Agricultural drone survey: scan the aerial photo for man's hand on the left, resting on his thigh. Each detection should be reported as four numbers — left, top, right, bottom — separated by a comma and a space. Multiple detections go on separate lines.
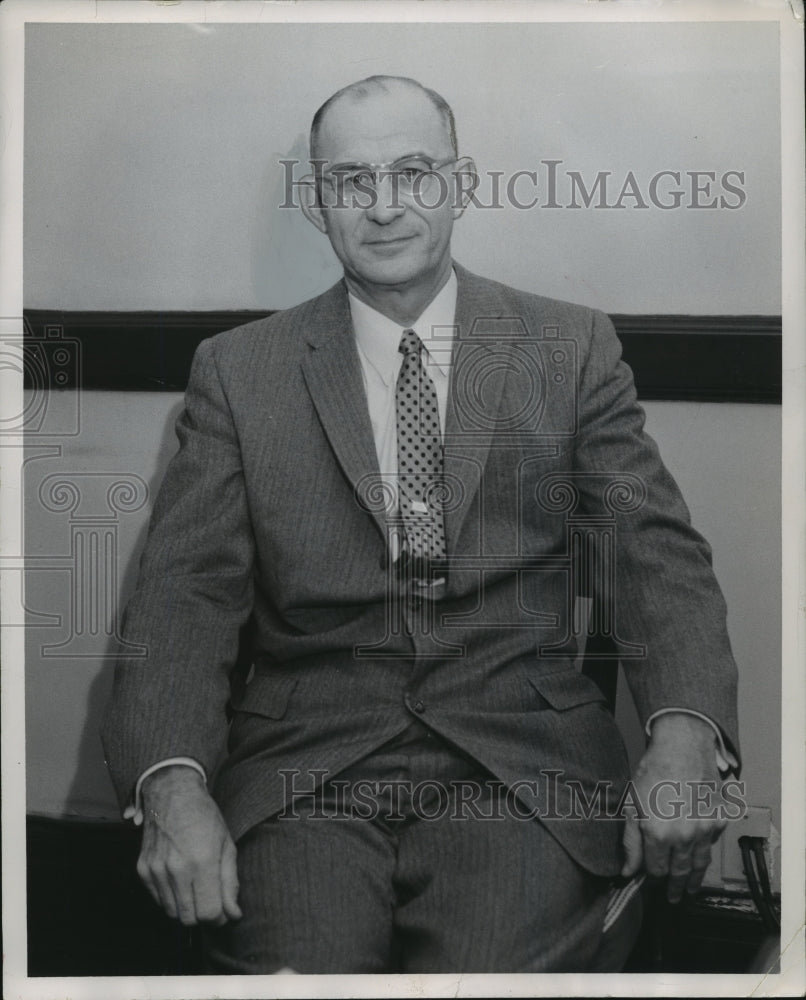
137, 764, 241, 926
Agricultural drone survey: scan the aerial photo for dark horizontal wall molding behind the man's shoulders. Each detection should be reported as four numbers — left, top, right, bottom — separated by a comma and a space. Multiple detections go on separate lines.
24, 309, 781, 403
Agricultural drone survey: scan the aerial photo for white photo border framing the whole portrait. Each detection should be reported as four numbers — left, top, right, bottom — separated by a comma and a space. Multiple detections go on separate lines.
0, 0, 806, 1000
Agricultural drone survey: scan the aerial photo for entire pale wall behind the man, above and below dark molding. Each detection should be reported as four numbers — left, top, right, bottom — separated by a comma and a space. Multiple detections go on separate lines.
25, 24, 780, 828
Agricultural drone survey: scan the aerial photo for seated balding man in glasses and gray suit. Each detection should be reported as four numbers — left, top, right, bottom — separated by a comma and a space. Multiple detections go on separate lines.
104, 77, 738, 972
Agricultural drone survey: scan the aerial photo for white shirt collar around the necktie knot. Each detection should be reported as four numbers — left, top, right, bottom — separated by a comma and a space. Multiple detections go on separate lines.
349, 269, 457, 385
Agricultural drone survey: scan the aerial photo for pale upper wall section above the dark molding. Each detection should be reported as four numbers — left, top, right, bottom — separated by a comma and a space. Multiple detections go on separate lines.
25, 23, 780, 314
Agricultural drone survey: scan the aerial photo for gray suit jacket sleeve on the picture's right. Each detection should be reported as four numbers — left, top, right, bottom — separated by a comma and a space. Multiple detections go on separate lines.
575, 312, 739, 759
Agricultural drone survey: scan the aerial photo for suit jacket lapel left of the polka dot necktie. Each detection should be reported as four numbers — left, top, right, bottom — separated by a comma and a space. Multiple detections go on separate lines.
302, 282, 386, 539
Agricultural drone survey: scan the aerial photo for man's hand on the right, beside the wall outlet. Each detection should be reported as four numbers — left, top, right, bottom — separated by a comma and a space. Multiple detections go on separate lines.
621, 712, 726, 903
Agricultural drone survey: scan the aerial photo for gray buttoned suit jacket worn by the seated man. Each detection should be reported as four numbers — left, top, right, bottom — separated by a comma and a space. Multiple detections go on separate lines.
103, 266, 738, 874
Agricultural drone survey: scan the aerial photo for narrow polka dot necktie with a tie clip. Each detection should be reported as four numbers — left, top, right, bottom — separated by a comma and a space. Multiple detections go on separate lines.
395, 330, 446, 579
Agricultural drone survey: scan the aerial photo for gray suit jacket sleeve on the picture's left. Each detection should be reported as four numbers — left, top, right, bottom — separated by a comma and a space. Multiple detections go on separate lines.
101, 339, 254, 808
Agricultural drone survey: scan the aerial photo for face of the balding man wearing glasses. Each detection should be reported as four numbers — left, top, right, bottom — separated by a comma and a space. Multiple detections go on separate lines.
315, 88, 460, 290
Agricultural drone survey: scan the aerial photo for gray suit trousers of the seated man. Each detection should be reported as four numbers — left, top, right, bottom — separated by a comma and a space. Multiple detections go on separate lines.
205, 719, 626, 974
